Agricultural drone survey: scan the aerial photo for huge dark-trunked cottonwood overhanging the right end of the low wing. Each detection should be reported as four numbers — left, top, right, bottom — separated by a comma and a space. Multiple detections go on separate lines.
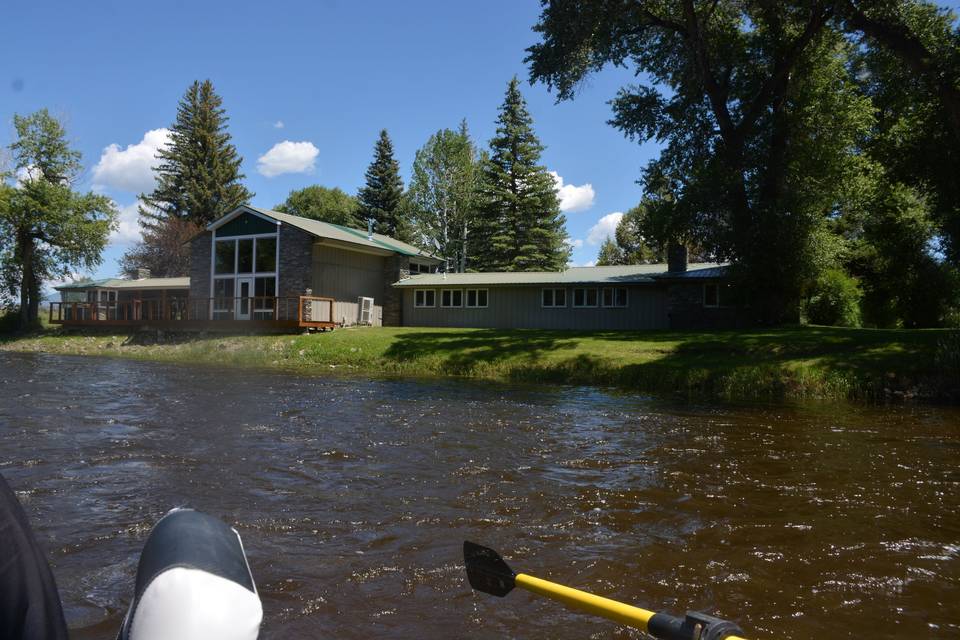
527, 0, 872, 323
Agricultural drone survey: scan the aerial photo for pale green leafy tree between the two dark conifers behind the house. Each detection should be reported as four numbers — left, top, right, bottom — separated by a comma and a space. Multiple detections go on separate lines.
408, 121, 479, 272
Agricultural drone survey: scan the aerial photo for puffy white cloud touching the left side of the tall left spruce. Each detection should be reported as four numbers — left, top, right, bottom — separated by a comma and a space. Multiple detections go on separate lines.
93, 129, 170, 193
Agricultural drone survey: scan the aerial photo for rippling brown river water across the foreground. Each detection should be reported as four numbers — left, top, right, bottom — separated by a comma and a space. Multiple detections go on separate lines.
0, 353, 960, 640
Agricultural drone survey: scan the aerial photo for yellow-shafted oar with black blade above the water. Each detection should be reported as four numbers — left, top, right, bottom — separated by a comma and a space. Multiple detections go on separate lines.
463, 541, 744, 640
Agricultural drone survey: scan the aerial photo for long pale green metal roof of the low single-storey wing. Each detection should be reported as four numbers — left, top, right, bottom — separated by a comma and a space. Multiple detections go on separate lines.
393, 263, 725, 287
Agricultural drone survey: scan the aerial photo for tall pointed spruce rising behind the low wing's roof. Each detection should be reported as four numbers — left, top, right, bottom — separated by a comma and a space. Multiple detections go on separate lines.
471, 77, 570, 271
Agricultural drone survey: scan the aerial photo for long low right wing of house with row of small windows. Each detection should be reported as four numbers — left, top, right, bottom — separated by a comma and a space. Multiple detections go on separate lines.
394, 255, 737, 331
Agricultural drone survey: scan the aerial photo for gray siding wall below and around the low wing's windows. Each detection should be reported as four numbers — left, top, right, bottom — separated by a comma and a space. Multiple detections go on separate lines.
403, 286, 669, 331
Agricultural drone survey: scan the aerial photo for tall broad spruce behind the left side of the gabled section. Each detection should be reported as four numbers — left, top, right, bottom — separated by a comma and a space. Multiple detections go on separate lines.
140, 80, 253, 227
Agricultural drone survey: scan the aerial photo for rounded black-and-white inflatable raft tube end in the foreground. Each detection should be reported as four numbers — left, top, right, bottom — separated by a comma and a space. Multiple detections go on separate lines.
117, 509, 263, 640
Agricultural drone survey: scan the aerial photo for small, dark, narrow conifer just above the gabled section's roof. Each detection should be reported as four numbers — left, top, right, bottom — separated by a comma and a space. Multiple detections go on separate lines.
357, 129, 410, 240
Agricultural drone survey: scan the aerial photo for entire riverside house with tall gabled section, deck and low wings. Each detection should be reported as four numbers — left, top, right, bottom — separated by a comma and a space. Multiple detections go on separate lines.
51, 206, 741, 330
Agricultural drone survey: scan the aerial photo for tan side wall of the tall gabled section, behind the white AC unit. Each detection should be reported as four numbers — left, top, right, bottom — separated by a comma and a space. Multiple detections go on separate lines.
313, 243, 386, 325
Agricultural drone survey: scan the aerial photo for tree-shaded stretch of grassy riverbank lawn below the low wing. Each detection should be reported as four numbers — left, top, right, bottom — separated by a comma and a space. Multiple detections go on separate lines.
385, 327, 956, 399
